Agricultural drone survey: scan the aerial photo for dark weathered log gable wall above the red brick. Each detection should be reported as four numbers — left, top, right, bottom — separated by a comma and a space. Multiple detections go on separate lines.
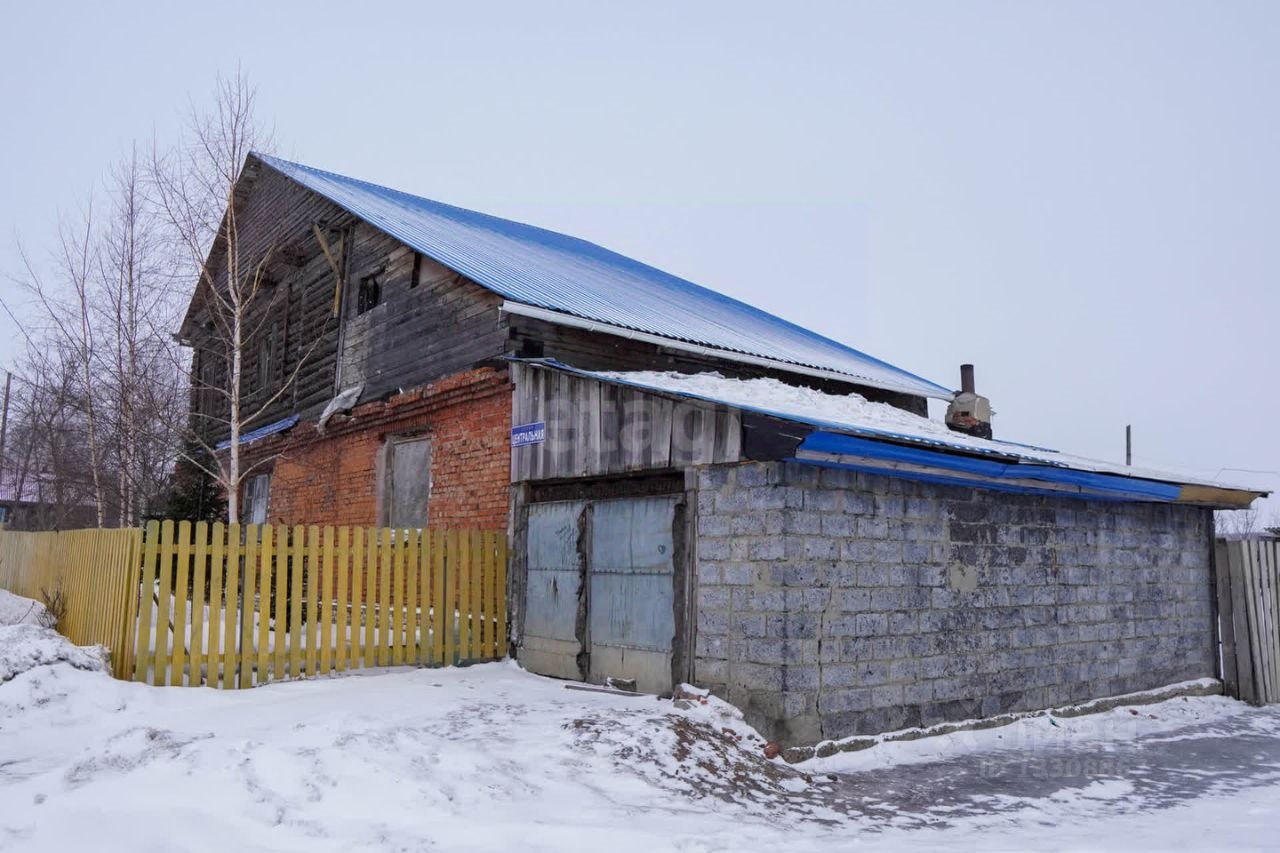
186, 160, 507, 442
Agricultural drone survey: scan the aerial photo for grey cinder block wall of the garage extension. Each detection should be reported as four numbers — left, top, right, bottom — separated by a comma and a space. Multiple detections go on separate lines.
695, 462, 1216, 743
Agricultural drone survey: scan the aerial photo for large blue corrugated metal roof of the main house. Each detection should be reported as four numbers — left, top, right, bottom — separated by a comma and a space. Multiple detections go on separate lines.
255, 155, 952, 400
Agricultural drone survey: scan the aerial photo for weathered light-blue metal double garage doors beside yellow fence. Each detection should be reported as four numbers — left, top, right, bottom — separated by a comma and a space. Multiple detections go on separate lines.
521, 496, 681, 693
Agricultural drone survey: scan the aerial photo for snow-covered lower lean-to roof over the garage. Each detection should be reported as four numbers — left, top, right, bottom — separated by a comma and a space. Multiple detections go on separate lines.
586, 365, 1267, 493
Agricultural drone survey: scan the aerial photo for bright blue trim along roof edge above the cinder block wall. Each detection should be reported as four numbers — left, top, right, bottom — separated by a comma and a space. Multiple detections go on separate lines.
797, 430, 1181, 502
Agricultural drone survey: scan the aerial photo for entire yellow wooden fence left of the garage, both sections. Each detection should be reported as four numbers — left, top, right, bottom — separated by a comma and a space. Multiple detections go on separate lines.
0, 521, 507, 688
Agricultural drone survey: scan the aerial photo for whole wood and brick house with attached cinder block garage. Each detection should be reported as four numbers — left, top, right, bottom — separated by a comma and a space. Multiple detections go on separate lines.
182, 155, 1261, 743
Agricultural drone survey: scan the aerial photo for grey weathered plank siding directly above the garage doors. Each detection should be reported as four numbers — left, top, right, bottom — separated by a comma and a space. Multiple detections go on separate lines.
511, 364, 742, 483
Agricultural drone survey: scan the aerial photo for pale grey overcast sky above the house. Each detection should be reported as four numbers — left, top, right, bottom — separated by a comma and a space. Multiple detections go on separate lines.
0, 0, 1280, 512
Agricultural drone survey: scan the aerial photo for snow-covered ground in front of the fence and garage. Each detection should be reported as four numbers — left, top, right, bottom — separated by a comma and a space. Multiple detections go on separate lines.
0, 625, 1280, 853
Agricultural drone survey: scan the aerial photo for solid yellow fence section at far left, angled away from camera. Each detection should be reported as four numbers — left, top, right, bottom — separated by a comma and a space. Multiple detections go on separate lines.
0, 529, 142, 679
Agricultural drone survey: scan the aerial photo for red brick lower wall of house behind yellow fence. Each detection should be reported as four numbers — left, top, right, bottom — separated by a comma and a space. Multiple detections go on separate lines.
246, 368, 512, 529
